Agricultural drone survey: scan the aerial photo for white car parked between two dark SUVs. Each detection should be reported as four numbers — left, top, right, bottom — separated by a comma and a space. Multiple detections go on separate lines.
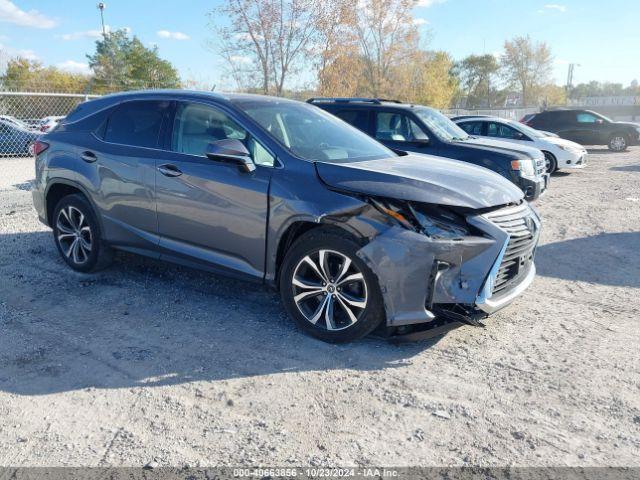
454, 117, 587, 173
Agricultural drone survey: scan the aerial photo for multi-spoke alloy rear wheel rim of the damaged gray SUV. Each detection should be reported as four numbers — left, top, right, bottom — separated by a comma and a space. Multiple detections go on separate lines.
56, 205, 93, 265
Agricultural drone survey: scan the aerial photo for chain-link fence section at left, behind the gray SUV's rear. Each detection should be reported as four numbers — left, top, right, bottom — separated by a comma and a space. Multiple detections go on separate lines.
0, 91, 96, 156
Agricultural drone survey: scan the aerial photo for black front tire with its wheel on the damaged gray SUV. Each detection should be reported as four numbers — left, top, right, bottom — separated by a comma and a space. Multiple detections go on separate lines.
279, 229, 385, 343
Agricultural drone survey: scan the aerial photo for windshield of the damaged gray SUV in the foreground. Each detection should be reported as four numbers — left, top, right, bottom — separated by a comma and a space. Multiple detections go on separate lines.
232, 99, 396, 163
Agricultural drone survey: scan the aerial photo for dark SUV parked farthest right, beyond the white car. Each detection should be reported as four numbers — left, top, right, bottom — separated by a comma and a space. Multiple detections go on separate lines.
520, 110, 640, 152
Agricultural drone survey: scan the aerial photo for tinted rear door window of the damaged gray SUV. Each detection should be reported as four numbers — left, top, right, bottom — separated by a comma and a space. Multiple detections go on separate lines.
104, 100, 170, 148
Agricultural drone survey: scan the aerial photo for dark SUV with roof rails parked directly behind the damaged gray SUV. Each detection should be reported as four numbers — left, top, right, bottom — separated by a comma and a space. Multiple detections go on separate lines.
307, 98, 549, 200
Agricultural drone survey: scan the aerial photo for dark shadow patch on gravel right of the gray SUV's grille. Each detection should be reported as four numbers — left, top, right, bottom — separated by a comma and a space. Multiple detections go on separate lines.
536, 232, 640, 288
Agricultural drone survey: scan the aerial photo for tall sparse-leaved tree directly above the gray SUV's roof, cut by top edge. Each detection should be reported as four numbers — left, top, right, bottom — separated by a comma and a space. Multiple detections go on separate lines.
210, 0, 323, 95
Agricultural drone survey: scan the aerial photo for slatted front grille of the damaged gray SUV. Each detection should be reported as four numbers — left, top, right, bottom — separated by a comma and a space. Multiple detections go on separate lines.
486, 204, 537, 294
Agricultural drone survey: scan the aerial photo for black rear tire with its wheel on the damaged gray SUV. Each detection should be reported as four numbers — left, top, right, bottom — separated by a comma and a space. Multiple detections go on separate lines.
51, 194, 113, 273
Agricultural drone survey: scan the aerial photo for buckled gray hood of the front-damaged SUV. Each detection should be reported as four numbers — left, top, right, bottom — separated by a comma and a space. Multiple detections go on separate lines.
315, 155, 524, 209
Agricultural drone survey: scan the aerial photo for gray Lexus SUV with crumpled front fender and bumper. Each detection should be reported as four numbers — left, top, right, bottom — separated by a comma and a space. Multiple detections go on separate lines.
33, 91, 540, 342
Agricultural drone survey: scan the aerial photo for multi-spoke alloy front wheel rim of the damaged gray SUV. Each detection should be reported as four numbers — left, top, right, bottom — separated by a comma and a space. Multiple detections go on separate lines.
291, 250, 367, 331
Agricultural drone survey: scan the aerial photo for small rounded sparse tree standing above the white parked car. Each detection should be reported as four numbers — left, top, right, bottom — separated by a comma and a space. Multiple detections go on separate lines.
500, 36, 553, 105
